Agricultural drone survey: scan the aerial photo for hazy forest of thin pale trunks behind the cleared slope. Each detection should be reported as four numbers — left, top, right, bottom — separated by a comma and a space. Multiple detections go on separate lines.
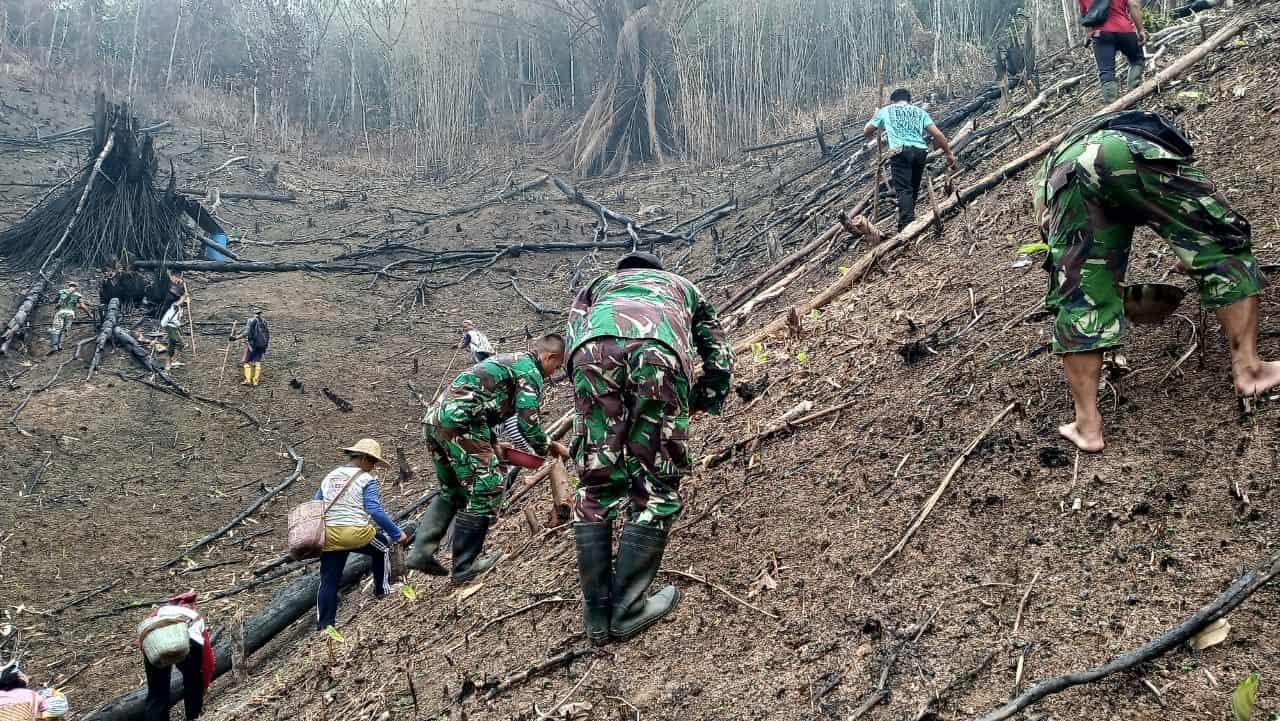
0, 0, 1157, 177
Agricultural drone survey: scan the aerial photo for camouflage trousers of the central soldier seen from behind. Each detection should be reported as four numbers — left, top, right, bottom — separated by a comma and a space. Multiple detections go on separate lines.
572, 338, 692, 528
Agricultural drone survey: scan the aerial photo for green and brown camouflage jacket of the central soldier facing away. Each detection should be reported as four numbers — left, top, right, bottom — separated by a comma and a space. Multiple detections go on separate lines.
566, 269, 733, 414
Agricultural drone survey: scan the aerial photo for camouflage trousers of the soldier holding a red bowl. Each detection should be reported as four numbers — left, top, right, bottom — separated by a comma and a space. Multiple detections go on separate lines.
422, 423, 503, 516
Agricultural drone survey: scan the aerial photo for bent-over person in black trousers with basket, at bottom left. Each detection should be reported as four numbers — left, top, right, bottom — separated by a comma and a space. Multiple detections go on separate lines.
138, 593, 214, 721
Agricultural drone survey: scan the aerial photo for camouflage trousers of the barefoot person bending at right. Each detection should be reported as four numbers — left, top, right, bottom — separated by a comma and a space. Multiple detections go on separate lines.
1044, 134, 1267, 353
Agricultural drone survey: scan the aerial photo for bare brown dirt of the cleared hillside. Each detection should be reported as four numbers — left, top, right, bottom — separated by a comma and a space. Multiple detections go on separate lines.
0, 7, 1280, 721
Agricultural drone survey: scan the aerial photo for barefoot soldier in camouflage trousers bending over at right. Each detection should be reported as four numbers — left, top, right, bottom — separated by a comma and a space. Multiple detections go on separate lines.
1034, 112, 1280, 452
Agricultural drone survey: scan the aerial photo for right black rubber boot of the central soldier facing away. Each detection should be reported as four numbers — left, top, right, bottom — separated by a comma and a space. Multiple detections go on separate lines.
609, 524, 680, 640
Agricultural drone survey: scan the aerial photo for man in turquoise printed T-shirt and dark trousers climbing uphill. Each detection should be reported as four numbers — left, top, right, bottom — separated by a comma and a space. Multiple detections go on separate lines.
863, 87, 956, 231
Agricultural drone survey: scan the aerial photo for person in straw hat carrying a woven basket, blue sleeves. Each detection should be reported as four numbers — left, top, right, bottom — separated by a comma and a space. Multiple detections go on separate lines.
315, 438, 408, 630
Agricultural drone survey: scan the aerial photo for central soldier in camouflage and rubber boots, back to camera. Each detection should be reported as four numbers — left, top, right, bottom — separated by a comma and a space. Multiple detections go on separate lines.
568, 254, 733, 644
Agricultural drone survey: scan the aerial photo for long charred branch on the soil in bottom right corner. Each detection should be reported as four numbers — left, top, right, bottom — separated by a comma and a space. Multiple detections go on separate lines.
977, 553, 1280, 721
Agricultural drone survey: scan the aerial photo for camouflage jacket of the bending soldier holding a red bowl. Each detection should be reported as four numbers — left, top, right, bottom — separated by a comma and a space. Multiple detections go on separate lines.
422, 352, 548, 456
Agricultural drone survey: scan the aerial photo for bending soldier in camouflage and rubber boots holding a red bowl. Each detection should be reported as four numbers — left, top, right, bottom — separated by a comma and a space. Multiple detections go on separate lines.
404, 334, 568, 583
